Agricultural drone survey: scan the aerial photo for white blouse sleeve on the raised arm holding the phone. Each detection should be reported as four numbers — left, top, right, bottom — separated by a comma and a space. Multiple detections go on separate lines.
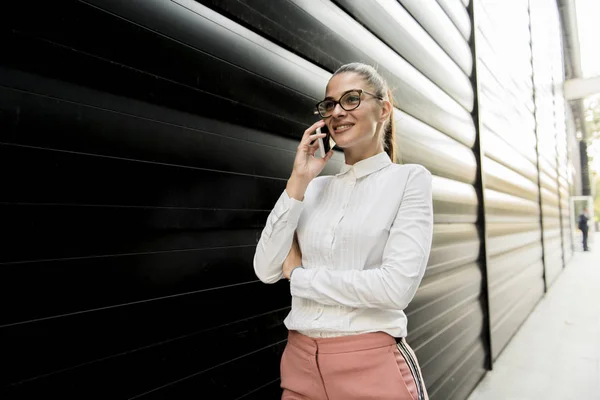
254, 190, 303, 283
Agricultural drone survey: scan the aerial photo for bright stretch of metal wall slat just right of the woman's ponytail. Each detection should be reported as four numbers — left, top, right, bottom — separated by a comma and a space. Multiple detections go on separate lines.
394, 110, 477, 184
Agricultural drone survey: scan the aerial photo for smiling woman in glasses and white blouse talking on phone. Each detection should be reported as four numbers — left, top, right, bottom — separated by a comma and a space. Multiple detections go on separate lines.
254, 63, 433, 400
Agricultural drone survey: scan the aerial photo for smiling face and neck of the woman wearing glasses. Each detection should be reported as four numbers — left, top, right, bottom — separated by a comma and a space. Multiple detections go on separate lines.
324, 72, 391, 164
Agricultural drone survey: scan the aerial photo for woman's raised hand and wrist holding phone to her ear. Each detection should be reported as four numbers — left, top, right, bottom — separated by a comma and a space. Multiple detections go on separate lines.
286, 120, 333, 200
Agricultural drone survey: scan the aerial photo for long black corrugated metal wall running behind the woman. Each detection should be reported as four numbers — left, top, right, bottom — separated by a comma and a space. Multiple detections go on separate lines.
0, 0, 569, 400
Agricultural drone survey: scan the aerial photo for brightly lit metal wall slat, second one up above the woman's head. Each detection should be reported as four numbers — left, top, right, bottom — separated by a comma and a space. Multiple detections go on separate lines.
336, 0, 474, 111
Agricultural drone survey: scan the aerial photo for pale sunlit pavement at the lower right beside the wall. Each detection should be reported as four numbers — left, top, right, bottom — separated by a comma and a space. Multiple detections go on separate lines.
468, 233, 600, 400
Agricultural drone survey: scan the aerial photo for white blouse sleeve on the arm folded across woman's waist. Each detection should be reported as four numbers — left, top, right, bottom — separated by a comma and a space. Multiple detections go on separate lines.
284, 167, 433, 310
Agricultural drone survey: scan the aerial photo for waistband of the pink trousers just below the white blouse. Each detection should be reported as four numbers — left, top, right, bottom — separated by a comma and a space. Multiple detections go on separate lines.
288, 331, 396, 355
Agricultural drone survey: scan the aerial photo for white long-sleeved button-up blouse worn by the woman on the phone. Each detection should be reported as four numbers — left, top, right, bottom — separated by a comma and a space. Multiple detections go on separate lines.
254, 152, 433, 337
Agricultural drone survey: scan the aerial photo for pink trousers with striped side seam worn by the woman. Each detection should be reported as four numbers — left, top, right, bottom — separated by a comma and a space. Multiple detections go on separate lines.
281, 331, 428, 400
